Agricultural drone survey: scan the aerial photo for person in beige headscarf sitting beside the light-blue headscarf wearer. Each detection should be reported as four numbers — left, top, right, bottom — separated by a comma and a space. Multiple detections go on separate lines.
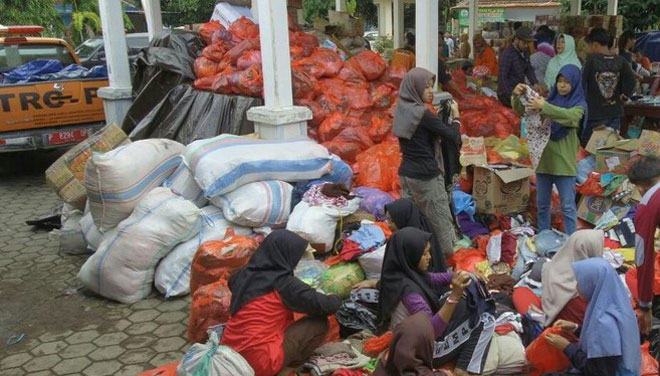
513, 230, 604, 342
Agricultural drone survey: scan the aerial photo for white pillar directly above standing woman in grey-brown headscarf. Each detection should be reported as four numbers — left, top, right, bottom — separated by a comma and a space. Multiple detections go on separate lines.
415, 0, 438, 78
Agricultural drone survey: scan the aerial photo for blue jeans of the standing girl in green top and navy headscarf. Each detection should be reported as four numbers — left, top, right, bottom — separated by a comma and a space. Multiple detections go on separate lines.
536, 174, 577, 235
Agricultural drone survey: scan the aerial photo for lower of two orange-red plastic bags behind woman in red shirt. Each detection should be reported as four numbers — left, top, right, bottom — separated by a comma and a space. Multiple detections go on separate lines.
188, 279, 231, 343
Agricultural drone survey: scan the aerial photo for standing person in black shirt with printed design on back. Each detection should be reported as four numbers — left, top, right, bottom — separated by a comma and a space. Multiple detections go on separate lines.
580, 27, 636, 146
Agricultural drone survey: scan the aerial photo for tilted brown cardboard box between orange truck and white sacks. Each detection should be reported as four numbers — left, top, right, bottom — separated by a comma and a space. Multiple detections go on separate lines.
46, 124, 131, 210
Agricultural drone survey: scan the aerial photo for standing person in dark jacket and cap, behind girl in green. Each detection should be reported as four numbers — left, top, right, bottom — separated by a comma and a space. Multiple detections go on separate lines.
497, 26, 539, 108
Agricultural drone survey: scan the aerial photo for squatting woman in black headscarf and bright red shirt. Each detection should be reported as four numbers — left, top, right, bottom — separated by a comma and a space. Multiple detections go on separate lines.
222, 230, 342, 376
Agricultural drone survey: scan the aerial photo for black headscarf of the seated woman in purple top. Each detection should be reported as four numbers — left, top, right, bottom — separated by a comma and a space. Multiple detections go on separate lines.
378, 227, 440, 332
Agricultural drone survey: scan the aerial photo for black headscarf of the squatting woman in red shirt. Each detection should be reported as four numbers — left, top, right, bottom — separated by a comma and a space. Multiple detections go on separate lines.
229, 230, 307, 315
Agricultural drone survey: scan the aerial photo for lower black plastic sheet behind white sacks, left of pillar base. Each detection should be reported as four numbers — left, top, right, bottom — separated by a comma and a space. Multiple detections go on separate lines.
129, 84, 262, 145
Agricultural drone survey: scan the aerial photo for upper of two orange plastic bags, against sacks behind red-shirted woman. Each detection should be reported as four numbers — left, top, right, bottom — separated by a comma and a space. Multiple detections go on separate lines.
190, 228, 259, 295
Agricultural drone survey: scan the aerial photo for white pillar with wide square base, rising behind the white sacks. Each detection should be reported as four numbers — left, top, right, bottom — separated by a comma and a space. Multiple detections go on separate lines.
247, 0, 312, 139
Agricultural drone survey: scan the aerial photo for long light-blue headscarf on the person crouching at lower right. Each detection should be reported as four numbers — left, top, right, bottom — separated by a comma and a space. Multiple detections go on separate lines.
572, 258, 641, 375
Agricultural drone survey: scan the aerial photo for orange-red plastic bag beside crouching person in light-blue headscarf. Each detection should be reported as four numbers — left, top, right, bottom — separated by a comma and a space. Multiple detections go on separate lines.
525, 326, 571, 376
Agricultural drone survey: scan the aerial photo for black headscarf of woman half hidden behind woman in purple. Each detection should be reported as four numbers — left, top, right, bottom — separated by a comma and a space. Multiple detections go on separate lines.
385, 198, 447, 273
